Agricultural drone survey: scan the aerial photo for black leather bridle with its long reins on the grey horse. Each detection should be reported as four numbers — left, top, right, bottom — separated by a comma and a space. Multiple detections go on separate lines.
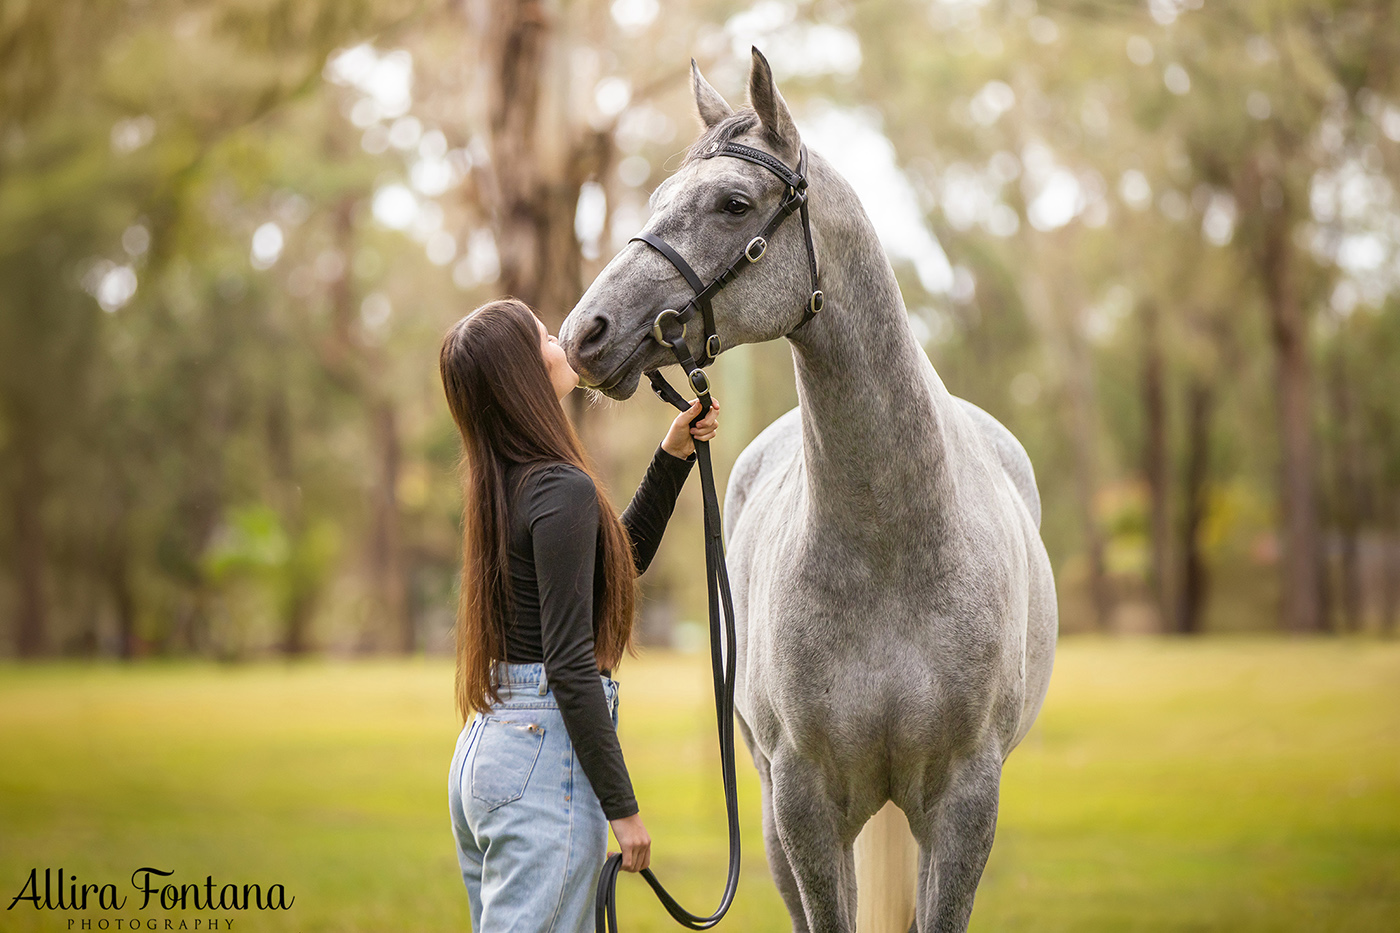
594, 143, 825, 933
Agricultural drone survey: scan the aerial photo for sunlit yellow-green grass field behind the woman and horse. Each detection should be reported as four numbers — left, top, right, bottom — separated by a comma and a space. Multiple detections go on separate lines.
0, 639, 1400, 933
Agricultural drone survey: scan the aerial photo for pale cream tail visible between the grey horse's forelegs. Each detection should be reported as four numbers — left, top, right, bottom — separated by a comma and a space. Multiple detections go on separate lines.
855, 803, 918, 933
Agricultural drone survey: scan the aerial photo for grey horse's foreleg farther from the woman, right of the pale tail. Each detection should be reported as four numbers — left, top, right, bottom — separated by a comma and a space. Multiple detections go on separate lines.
909, 749, 1001, 933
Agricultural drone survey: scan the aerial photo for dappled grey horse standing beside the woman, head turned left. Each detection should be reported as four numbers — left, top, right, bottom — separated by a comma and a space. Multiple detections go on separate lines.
560, 49, 1058, 933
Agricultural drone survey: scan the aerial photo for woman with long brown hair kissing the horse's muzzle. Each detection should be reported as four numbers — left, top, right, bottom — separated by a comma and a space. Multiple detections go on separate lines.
440, 298, 720, 933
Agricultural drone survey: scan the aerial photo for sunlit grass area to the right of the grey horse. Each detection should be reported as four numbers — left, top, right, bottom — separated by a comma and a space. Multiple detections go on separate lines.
973, 640, 1400, 930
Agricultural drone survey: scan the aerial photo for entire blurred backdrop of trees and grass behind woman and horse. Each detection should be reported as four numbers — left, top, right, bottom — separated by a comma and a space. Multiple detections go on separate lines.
0, 0, 1400, 930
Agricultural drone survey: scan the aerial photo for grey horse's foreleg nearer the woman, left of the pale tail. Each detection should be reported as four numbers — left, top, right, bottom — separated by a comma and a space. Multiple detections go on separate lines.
769, 751, 855, 933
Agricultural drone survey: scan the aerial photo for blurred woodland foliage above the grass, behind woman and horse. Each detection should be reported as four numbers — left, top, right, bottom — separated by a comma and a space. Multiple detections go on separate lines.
0, 0, 1400, 657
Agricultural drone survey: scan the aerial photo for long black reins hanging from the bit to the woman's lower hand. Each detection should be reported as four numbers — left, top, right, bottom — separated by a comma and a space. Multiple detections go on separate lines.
594, 343, 739, 933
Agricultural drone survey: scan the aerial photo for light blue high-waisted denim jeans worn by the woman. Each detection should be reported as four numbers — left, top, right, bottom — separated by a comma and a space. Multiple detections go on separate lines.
448, 663, 617, 933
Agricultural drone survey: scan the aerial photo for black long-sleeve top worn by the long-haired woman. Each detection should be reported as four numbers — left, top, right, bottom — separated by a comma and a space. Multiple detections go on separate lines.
505, 444, 694, 820
